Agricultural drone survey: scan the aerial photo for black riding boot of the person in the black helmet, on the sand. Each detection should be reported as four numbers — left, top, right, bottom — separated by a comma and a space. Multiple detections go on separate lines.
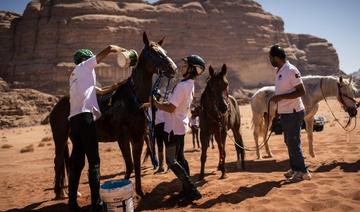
170, 162, 201, 202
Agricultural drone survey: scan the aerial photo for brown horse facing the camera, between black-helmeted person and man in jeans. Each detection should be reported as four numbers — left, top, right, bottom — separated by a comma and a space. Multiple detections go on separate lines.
200, 64, 245, 180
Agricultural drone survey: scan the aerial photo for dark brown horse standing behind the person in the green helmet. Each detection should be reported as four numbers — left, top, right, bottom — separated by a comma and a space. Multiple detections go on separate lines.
50, 32, 176, 198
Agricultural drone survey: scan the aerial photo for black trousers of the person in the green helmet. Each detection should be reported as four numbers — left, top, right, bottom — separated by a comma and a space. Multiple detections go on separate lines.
69, 113, 100, 205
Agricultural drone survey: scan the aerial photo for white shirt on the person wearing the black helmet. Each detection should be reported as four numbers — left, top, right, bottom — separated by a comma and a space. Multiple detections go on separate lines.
164, 79, 195, 135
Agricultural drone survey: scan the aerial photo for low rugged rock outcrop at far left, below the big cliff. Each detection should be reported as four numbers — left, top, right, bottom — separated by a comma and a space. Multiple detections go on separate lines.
0, 78, 58, 129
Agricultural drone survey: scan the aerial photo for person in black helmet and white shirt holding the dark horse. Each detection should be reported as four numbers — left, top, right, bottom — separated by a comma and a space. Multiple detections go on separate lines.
154, 55, 205, 203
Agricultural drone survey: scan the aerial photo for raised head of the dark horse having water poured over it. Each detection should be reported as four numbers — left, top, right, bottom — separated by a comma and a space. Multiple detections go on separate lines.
138, 32, 177, 78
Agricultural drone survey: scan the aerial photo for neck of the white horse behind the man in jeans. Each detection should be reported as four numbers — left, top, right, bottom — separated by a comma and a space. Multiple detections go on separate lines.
310, 77, 338, 102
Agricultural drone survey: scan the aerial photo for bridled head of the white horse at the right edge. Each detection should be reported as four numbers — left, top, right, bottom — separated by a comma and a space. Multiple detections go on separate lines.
337, 76, 359, 117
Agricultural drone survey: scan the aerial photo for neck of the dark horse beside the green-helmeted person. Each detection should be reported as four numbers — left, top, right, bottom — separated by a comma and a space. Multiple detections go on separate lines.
131, 64, 152, 102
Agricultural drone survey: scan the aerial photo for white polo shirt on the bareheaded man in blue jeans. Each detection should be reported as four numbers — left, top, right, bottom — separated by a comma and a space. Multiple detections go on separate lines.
275, 61, 304, 114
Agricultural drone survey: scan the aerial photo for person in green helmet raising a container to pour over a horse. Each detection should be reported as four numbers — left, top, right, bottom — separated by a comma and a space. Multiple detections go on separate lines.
68, 45, 124, 211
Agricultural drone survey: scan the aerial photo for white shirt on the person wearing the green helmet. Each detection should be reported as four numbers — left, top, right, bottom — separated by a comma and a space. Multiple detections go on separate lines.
68, 56, 101, 120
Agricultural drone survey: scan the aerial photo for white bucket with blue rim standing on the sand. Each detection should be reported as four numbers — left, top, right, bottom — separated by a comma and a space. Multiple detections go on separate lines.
100, 180, 134, 212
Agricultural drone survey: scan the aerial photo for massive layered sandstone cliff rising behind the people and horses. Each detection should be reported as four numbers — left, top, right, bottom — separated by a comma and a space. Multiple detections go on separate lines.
0, 0, 339, 93
